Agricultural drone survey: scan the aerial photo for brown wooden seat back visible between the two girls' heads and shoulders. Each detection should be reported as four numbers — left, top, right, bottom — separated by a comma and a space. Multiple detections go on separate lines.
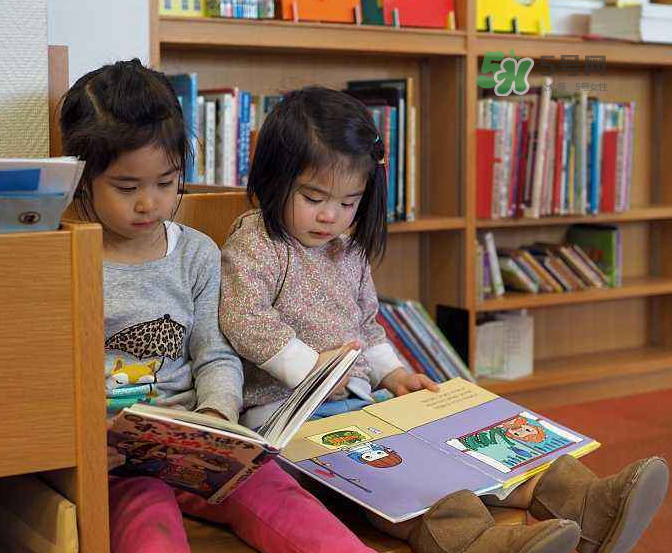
175, 191, 250, 246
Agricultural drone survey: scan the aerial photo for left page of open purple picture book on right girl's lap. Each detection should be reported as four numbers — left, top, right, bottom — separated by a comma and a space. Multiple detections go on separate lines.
281, 411, 499, 522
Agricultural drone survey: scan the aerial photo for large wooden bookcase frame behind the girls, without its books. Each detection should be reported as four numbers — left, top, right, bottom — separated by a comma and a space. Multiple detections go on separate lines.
150, 0, 672, 406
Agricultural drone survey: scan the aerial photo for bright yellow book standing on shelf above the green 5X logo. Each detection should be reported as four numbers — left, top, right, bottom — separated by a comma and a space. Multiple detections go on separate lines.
476, 0, 551, 35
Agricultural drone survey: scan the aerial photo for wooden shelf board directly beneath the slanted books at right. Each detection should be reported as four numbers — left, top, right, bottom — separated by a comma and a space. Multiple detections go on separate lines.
476, 277, 672, 312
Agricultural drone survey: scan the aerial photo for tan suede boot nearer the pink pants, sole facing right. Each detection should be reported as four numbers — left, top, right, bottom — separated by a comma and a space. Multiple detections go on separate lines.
409, 490, 579, 553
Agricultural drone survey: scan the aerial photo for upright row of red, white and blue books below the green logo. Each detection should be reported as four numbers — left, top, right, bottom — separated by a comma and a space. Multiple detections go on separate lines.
477, 78, 635, 219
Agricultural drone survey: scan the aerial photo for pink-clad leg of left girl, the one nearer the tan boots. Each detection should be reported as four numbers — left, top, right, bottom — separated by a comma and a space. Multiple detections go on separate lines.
176, 462, 375, 553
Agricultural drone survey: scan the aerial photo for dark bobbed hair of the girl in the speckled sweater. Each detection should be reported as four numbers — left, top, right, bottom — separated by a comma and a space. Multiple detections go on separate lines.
247, 86, 387, 259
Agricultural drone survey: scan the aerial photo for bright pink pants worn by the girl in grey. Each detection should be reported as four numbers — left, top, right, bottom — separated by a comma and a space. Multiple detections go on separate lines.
110, 462, 375, 553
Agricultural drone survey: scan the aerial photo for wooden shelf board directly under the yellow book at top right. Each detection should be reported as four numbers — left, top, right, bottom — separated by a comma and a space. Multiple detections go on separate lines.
473, 33, 672, 67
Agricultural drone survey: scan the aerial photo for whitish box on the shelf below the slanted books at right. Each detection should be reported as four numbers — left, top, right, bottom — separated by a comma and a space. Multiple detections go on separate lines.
475, 309, 534, 380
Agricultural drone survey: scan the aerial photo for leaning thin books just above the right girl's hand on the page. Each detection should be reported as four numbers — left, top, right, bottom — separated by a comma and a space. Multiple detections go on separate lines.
377, 298, 473, 382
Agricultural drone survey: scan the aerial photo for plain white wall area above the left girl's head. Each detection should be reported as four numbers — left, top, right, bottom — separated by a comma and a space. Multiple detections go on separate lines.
47, 0, 149, 85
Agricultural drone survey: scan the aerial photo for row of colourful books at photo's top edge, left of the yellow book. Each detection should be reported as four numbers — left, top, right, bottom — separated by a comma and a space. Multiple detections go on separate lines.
159, 0, 455, 29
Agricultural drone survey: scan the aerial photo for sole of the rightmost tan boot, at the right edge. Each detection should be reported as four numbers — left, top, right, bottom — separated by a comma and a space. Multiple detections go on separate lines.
598, 458, 670, 553
